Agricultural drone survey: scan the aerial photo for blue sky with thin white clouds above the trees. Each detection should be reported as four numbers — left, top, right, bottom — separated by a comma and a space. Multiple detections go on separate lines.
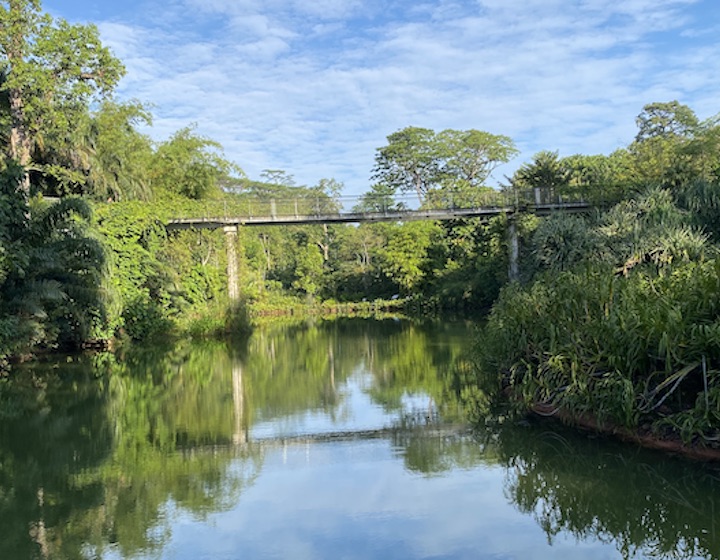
44, 0, 720, 194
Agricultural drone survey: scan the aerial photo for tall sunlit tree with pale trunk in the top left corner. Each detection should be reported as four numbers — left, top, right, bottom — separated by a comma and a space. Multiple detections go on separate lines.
0, 0, 125, 195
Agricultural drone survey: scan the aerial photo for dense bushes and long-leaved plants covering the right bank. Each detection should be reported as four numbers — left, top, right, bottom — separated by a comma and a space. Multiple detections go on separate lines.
482, 102, 720, 445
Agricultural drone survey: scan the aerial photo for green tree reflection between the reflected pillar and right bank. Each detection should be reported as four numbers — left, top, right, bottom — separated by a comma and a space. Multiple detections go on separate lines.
243, 319, 472, 423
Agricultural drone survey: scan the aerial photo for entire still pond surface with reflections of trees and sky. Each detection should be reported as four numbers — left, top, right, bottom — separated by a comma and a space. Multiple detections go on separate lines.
0, 319, 720, 560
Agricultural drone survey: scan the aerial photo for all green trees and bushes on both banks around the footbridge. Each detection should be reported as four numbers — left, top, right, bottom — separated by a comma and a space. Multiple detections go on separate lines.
0, 0, 720, 450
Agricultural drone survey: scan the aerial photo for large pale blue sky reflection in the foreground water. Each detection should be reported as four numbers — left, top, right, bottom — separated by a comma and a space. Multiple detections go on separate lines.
153, 440, 616, 560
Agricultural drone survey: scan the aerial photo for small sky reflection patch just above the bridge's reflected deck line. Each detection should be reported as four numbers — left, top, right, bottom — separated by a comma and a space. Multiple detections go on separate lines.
250, 370, 429, 441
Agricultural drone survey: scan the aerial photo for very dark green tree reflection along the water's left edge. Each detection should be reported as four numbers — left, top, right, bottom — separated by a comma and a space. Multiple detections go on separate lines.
0, 363, 112, 558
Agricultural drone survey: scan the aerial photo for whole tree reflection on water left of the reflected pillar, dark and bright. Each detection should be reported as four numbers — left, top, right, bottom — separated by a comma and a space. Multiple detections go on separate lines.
0, 343, 262, 558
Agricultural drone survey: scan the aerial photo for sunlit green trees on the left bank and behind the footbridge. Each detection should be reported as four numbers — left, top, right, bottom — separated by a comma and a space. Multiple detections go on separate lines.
0, 0, 515, 359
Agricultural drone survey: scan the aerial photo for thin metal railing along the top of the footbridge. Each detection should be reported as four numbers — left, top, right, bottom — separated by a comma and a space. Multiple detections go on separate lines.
169, 189, 580, 220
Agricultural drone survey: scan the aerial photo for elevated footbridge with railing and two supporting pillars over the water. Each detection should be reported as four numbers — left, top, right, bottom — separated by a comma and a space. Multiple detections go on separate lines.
166, 188, 590, 299
